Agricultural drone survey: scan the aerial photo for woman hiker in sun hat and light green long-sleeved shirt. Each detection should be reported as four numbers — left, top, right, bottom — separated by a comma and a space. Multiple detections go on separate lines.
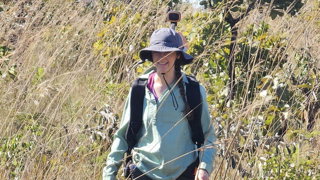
103, 28, 215, 180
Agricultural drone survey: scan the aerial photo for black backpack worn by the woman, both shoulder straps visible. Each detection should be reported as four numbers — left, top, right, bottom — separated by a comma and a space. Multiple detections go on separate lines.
125, 76, 204, 176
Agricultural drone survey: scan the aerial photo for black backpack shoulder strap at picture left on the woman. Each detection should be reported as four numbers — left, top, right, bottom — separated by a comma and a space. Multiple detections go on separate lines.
125, 78, 148, 154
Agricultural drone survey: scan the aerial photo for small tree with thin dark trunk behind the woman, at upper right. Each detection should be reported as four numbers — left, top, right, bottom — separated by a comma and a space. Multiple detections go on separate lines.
200, 0, 303, 101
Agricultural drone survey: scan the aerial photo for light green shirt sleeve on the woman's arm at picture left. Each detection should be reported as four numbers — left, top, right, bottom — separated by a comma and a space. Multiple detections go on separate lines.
102, 90, 131, 180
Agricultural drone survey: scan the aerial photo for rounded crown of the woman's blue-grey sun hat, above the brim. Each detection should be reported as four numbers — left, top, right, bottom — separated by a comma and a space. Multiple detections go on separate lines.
150, 28, 183, 49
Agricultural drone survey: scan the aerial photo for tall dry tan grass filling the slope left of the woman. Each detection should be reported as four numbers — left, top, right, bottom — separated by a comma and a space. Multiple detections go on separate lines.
0, 0, 189, 179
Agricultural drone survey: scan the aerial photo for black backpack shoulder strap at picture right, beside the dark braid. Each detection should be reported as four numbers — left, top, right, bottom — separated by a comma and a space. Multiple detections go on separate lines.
186, 76, 204, 148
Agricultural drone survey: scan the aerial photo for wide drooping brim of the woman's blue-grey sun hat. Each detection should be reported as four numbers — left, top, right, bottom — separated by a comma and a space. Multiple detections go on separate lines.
139, 45, 193, 65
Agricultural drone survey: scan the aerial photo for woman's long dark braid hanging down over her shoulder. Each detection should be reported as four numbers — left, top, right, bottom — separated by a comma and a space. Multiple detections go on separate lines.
174, 59, 192, 119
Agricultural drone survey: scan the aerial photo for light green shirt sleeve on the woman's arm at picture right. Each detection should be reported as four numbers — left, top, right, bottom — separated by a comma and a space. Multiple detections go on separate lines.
199, 85, 216, 174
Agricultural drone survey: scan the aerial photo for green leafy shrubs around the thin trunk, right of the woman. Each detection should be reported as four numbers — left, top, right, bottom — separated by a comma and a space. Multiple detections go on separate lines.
182, 1, 319, 179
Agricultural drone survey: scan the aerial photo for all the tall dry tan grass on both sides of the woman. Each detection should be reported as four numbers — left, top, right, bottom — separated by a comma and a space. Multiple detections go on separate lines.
0, 0, 319, 179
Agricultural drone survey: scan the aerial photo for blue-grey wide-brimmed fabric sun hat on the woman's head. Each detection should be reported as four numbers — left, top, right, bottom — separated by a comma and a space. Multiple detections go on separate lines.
139, 28, 193, 65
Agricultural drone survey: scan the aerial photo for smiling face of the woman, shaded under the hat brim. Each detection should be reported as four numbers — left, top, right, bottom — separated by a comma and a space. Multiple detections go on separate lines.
152, 52, 179, 73
